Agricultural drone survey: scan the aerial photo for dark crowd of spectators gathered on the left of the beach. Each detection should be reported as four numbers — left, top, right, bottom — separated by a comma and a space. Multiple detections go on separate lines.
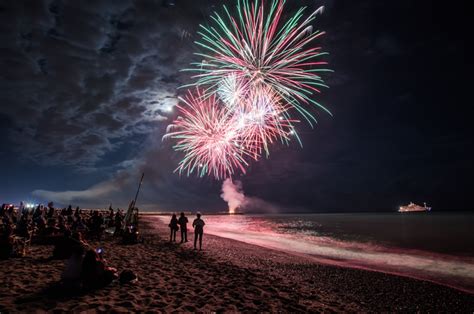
0, 203, 136, 289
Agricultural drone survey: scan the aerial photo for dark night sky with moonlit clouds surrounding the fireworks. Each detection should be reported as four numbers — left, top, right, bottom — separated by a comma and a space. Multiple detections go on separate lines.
0, 0, 474, 212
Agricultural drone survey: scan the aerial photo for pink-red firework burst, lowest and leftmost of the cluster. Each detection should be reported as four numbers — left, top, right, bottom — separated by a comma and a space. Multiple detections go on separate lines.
164, 90, 259, 179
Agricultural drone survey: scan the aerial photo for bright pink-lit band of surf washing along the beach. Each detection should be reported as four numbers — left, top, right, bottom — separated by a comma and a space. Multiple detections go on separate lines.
156, 217, 474, 293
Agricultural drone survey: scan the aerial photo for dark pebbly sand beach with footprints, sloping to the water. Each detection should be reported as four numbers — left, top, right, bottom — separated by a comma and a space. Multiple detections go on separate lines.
0, 216, 474, 313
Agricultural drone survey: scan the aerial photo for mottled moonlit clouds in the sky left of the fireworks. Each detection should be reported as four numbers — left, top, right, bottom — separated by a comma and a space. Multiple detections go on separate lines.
0, 0, 203, 168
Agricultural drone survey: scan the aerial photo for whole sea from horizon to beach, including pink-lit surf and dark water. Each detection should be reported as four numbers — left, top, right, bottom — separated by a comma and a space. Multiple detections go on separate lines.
156, 212, 474, 293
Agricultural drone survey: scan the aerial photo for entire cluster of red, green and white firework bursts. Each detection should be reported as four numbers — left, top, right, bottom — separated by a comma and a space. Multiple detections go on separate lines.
164, 0, 329, 179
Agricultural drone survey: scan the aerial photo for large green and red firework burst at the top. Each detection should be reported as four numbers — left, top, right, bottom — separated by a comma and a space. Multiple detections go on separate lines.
185, 0, 330, 126
